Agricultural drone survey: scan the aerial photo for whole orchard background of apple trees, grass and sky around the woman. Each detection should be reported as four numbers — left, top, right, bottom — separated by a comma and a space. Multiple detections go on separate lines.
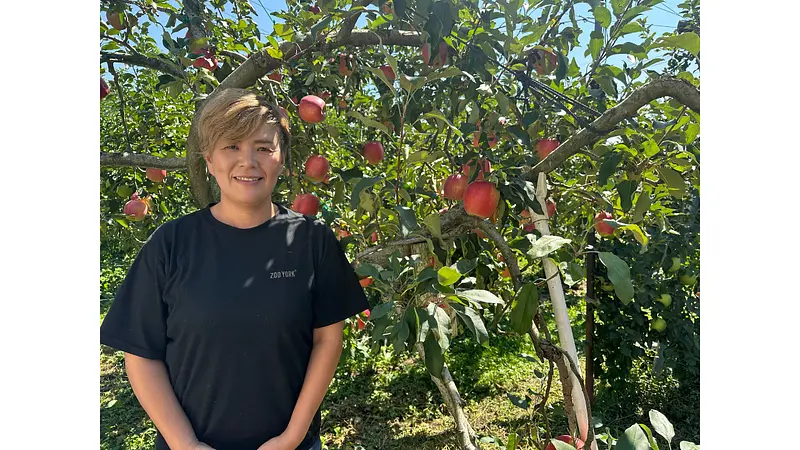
100, 0, 700, 450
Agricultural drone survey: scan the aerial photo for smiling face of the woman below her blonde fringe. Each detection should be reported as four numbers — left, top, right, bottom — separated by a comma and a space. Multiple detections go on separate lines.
206, 125, 283, 207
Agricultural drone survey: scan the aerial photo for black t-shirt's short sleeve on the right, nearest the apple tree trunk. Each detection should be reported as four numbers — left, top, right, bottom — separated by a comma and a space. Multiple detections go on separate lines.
313, 224, 369, 328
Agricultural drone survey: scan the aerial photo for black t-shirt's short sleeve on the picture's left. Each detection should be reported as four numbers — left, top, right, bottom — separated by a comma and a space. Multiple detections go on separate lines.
100, 231, 167, 359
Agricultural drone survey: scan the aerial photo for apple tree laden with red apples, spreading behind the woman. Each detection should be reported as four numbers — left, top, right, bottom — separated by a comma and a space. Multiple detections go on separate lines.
100, 0, 700, 449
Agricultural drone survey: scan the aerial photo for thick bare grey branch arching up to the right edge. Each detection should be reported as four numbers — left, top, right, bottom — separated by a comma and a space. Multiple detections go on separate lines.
523, 77, 700, 182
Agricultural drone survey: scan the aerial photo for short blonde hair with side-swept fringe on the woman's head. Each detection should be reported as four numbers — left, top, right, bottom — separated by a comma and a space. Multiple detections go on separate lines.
197, 88, 292, 162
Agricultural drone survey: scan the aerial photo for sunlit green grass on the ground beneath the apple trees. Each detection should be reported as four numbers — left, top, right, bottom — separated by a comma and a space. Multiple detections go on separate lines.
100, 303, 699, 450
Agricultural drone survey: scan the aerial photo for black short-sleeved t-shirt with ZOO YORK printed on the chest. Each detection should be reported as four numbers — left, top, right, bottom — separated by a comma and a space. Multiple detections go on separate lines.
100, 205, 369, 450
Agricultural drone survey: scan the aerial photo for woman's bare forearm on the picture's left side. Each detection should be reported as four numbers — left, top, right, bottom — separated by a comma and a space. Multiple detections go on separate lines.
125, 353, 198, 450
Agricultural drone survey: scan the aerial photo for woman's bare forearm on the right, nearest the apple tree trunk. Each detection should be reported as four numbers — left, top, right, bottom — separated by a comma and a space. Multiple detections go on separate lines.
272, 321, 344, 448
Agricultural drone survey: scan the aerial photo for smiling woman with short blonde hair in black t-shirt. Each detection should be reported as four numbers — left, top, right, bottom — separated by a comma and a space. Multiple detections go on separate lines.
100, 89, 368, 450
